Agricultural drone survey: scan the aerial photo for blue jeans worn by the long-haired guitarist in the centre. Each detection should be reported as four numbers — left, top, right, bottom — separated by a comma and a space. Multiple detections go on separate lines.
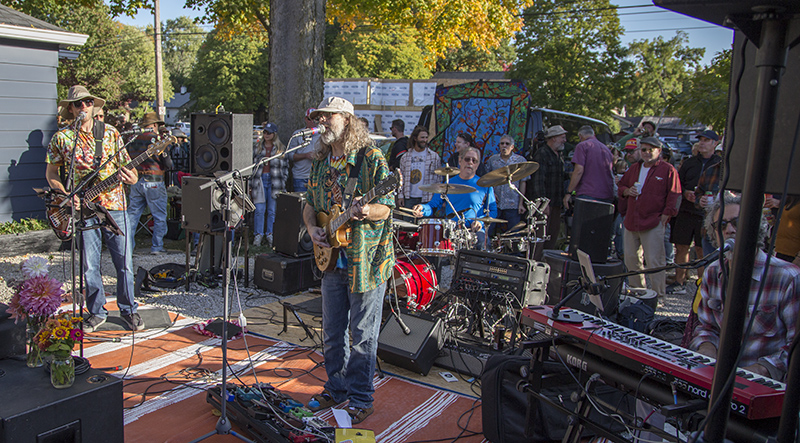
322, 269, 386, 408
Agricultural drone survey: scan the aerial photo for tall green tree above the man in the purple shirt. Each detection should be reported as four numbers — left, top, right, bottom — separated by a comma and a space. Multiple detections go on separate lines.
510, 0, 630, 121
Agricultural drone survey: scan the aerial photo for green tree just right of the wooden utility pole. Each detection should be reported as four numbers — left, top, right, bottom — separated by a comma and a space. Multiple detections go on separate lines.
155, 15, 206, 91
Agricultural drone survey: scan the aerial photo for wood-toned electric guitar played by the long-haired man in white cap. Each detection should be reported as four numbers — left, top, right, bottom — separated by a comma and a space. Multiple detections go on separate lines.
314, 171, 402, 271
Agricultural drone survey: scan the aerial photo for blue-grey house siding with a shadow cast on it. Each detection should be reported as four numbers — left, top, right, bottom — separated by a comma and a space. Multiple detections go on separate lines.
0, 38, 58, 222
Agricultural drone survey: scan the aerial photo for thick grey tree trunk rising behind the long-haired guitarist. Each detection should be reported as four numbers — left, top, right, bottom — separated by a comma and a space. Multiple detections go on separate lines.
269, 0, 325, 143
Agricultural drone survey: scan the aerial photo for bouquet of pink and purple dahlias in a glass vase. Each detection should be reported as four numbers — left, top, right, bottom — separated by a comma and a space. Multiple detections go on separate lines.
8, 257, 64, 368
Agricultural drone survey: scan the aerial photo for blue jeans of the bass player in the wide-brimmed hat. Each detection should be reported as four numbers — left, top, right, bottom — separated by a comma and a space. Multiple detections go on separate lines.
83, 211, 138, 317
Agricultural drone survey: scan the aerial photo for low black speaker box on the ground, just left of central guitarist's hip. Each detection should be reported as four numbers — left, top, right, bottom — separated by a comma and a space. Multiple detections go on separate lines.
253, 254, 322, 295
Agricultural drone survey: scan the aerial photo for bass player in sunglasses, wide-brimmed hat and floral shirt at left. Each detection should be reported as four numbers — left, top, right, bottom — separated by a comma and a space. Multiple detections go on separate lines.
45, 86, 144, 332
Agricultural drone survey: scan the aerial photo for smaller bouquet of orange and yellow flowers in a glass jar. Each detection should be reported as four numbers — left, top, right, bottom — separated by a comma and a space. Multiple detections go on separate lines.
35, 314, 83, 388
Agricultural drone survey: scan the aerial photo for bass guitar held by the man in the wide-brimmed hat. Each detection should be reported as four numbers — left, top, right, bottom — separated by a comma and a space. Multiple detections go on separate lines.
43, 135, 178, 241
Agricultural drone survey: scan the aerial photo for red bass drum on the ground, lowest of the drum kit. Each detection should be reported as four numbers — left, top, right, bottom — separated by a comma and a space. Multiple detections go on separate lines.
393, 257, 437, 311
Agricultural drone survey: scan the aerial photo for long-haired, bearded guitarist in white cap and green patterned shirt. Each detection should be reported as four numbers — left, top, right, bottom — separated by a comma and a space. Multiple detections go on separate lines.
303, 97, 395, 424
